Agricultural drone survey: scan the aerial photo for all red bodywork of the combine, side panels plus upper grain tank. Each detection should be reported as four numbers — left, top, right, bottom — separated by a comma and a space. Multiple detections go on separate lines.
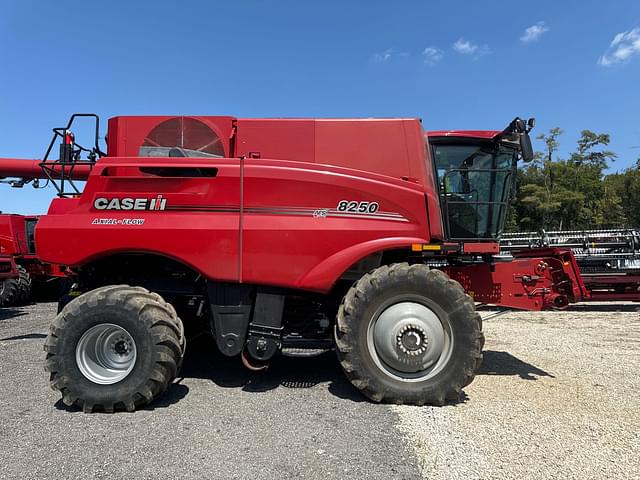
36, 117, 442, 291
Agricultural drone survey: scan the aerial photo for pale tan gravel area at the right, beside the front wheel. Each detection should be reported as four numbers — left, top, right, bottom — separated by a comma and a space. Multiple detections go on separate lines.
394, 304, 640, 479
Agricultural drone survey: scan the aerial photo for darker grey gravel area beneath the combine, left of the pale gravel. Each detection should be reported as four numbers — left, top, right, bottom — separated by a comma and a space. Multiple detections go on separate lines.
0, 304, 420, 479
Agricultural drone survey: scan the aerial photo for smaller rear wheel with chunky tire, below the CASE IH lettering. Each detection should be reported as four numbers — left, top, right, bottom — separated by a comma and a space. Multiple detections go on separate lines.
44, 285, 185, 413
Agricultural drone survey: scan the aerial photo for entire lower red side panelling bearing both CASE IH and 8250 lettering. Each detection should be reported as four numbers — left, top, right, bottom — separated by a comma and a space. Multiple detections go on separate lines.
36, 157, 429, 291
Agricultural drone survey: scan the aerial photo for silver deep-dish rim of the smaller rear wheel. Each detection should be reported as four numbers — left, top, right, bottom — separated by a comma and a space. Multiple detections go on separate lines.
76, 323, 137, 385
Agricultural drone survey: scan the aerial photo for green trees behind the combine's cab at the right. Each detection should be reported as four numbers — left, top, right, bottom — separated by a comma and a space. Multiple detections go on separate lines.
506, 128, 640, 232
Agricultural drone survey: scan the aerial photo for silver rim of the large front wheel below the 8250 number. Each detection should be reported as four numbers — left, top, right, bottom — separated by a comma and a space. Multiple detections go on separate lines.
367, 298, 453, 382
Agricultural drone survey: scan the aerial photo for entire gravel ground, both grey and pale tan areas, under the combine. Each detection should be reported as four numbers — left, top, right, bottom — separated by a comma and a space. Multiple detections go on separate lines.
0, 304, 640, 479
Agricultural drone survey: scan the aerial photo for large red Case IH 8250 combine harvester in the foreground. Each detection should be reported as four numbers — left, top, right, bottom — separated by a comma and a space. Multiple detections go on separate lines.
0, 115, 588, 412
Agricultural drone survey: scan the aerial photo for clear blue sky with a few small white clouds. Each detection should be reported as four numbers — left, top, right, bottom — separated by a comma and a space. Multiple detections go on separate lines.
0, 0, 640, 213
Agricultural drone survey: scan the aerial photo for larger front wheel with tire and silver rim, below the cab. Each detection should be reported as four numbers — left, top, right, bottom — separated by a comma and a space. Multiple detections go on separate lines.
335, 263, 484, 405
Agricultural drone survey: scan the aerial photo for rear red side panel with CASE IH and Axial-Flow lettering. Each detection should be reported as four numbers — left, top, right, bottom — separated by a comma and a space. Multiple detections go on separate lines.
36, 157, 240, 281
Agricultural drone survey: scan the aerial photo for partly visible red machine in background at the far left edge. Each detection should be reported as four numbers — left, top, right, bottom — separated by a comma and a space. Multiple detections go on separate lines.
0, 213, 68, 307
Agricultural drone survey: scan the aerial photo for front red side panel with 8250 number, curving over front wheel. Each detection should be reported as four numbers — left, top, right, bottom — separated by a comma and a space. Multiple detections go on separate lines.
242, 159, 429, 291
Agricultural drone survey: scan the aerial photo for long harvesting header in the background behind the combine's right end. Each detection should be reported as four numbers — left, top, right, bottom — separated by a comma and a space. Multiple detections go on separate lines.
500, 229, 640, 302
